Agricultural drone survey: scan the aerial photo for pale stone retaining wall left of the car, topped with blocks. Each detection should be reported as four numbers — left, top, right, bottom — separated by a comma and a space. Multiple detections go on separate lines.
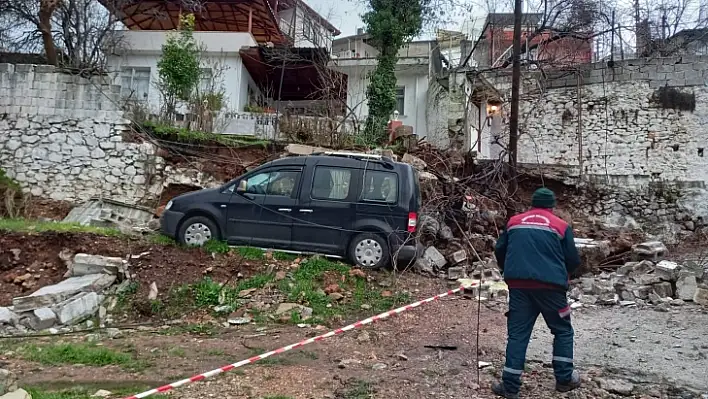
0, 64, 217, 204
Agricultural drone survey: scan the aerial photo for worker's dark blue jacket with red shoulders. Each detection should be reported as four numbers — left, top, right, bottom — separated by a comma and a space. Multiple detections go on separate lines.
494, 208, 580, 289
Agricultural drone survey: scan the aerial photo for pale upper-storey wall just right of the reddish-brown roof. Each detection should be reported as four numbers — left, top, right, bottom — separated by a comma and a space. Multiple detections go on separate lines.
278, 7, 332, 49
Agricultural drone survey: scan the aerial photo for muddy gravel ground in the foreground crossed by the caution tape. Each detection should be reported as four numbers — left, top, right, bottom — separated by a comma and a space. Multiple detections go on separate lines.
0, 277, 706, 399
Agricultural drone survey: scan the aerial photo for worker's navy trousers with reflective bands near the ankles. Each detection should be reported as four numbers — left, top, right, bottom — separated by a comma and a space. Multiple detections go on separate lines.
502, 288, 573, 393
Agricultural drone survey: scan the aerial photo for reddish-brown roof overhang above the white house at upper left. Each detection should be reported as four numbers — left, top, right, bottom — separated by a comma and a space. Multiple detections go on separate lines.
99, 0, 286, 44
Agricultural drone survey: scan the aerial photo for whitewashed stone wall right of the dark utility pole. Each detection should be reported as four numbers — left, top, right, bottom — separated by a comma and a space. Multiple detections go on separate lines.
487, 57, 708, 229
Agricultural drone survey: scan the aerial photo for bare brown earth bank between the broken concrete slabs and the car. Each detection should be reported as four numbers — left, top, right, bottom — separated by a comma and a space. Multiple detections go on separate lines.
0, 232, 262, 306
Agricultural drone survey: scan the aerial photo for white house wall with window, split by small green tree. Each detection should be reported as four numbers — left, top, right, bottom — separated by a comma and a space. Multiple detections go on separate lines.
108, 31, 258, 118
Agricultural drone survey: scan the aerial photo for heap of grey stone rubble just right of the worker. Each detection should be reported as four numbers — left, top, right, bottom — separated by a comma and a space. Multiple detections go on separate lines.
570, 260, 708, 310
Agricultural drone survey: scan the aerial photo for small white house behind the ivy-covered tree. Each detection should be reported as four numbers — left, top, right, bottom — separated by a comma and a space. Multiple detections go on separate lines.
331, 34, 436, 137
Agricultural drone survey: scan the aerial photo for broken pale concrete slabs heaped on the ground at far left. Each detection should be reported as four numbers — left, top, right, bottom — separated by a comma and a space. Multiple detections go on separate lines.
0, 254, 130, 335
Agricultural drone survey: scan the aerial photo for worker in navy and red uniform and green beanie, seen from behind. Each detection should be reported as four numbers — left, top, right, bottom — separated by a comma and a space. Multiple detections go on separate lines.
492, 188, 580, 399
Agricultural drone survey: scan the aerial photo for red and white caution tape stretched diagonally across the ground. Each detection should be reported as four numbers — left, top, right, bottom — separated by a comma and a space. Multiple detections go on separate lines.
125, 283, 477, 399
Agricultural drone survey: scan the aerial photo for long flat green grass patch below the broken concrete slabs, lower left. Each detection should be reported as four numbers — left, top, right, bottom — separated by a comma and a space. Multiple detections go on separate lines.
17, 343, 146, 370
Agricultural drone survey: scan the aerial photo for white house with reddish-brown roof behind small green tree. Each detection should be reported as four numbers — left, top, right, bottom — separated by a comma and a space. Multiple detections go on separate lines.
101, 0, 339, 134
